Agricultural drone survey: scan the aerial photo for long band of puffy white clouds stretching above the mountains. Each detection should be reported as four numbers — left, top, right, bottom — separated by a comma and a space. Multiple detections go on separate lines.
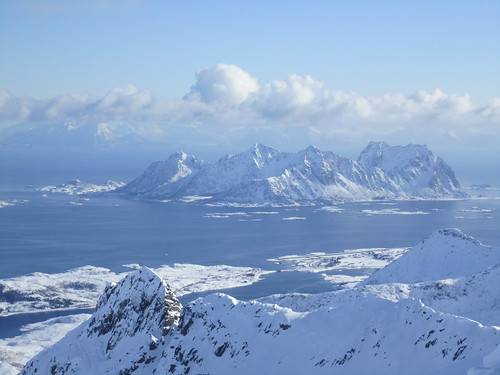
0, 64, 500, 152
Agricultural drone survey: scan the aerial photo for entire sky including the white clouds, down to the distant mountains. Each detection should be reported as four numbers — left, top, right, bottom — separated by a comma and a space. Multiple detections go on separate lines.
0, 0, 500, 184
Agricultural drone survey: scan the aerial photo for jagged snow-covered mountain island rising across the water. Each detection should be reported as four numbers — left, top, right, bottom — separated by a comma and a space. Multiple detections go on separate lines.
116, 142, 466, 204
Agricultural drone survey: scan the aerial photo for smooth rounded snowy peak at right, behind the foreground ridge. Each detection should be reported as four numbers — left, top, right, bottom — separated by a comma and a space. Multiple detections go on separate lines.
365, 228, 500, 284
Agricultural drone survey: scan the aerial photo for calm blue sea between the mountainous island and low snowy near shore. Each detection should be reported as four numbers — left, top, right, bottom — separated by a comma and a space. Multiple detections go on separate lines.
0, 187, 500, 279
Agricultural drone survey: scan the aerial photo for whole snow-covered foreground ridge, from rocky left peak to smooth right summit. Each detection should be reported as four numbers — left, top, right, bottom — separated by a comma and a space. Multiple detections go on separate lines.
21, 229, 500, 375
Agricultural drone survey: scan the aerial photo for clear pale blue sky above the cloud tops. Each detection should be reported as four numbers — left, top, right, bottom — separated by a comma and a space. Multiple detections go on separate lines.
0, 0, 500, 104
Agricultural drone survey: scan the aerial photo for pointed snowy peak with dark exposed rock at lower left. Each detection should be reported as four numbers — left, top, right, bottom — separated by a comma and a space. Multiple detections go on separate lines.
21, 268, 182, 375
